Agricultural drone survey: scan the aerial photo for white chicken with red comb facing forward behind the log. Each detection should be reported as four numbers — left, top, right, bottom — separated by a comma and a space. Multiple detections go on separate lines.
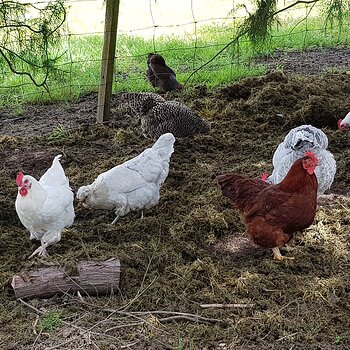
15, 155, 75, 258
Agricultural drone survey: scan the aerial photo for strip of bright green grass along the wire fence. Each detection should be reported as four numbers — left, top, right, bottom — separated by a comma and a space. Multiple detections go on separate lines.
0, 13, 350, 106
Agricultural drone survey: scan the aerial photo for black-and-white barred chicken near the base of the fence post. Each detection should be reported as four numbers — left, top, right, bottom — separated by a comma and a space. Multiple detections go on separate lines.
119, 93, 210, 139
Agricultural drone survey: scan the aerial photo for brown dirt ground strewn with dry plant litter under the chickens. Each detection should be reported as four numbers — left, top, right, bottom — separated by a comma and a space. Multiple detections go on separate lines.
0, 56, 350, 350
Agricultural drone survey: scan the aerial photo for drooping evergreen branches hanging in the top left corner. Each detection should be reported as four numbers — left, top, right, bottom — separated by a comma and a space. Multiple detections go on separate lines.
0, 0, 66, 87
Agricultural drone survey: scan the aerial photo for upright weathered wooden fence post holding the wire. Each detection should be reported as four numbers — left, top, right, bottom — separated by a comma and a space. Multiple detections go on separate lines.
97, 0, 119, 123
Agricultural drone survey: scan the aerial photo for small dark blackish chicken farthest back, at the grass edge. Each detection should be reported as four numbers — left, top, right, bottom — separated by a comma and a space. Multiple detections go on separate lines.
146, 53, 182, 92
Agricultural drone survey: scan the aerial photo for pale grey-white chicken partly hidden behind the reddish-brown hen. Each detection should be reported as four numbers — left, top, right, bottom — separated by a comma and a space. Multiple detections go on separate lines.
267, 125, 337, 197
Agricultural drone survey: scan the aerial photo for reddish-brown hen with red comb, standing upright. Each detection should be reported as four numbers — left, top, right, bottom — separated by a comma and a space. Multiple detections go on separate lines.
216, 152, 318, 260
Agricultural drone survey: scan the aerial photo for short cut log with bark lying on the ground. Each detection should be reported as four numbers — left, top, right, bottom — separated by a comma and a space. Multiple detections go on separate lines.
11, 258, 120, 299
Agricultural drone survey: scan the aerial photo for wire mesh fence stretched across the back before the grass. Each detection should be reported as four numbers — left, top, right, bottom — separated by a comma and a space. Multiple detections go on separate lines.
0, 0, 350, 105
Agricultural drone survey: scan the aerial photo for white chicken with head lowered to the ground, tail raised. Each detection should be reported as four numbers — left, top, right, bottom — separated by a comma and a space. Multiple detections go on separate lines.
77, 133, 175, 224
